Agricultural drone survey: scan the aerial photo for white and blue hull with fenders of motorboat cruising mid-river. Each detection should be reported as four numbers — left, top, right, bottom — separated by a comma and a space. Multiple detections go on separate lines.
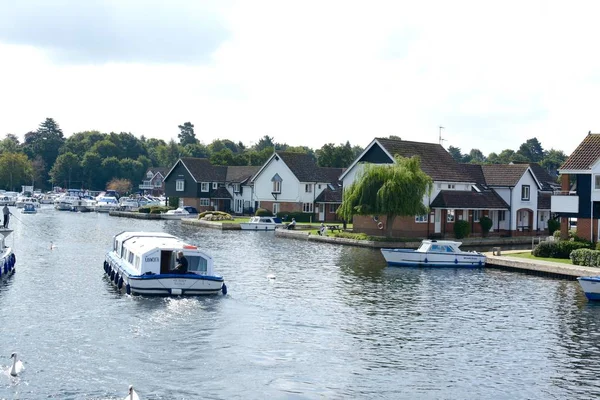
104, 257, 227, 296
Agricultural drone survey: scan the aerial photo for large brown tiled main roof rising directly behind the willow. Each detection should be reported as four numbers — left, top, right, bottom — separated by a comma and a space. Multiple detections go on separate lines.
376, 138, 471, 182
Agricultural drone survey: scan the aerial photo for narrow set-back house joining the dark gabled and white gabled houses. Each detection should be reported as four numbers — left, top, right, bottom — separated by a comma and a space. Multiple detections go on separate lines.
225, 166, 260, 214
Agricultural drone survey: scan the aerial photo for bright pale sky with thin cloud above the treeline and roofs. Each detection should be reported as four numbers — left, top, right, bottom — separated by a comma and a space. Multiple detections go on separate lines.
0, 0, 600, 155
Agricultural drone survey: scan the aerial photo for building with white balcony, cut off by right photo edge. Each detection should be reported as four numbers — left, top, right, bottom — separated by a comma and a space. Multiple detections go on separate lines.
551, 132, 600, 242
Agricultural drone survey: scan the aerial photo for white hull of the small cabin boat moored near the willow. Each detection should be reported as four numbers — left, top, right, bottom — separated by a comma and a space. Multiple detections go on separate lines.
381, 249, 486, 268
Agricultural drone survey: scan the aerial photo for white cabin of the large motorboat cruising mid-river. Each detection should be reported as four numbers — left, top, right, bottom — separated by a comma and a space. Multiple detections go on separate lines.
112, 232, 213, 275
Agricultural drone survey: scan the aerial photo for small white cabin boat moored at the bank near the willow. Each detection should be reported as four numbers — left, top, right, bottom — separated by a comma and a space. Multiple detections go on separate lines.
381, 240, 486, 267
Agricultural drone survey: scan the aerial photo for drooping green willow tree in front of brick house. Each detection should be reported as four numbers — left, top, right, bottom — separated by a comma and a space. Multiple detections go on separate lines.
338, 156, 433, 237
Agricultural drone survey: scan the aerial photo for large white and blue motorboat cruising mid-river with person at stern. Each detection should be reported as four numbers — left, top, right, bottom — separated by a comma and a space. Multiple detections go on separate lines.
104, 232, 227, 296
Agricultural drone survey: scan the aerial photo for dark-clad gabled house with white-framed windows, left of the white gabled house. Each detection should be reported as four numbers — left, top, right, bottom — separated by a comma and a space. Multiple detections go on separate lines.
164, 157, 233, 212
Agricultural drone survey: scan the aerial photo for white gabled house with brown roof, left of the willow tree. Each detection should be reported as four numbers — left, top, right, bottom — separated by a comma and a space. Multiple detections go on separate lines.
252, 152, 343, 221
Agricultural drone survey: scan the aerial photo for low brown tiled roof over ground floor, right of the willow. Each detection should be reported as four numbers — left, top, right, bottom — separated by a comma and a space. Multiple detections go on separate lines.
431, 190, 509, 210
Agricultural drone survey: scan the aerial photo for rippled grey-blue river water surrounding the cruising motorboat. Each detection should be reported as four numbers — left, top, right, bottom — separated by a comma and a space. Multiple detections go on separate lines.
0, 207, 600, 399
